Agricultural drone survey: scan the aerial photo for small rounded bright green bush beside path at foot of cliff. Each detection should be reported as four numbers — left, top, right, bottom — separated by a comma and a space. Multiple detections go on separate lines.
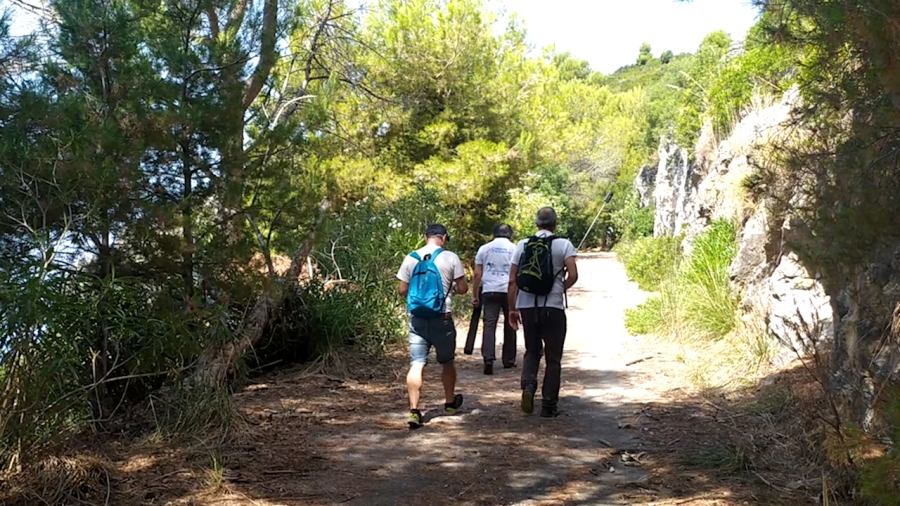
616, 237, 681, 291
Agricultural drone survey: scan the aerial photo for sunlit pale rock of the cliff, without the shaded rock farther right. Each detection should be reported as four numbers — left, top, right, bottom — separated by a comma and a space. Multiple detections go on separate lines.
653, 91, 833, 359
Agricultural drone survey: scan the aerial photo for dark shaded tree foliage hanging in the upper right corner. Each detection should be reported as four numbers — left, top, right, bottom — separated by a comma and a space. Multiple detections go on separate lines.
761, 0, 900, 279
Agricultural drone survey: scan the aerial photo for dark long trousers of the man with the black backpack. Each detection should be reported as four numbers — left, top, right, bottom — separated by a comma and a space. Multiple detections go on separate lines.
519, 307, 566, 406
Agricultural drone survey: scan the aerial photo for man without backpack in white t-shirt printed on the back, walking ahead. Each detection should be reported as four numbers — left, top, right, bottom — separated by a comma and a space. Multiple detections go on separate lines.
472, 224, 516, 374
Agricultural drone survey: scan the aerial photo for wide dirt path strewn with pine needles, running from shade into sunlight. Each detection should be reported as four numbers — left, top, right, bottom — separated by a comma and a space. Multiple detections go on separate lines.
128, 253, 816, 506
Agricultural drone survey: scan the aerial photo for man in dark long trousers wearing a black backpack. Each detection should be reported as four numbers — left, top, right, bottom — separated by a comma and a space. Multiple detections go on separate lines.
508, 207, 578, 418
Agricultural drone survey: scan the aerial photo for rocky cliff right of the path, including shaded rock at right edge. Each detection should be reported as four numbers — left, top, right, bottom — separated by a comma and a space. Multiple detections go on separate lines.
639, 87, 900, 430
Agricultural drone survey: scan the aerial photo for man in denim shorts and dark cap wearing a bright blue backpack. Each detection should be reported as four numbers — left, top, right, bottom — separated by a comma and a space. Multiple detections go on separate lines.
397, 224, 469, 429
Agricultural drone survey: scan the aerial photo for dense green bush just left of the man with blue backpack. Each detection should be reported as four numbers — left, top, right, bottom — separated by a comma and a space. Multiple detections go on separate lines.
271, 186, 456, 360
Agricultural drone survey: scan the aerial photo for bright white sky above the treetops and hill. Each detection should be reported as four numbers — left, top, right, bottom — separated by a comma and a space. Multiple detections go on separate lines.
494, 0, 758, 74
